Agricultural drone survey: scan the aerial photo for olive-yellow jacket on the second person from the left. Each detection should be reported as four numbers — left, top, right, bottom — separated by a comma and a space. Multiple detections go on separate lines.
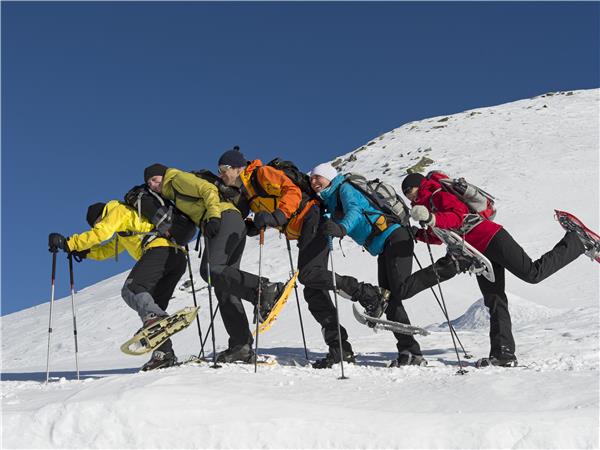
161, 168, 239, 225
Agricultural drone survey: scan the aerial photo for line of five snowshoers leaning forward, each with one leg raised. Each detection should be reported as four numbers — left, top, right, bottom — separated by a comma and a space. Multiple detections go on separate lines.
49, 147, 598, 370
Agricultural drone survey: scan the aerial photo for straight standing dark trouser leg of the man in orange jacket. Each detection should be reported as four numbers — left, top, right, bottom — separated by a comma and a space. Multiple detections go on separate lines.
298, 206, 348, 347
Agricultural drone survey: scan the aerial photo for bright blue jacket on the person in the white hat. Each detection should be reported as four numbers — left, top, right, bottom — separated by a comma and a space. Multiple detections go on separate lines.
320, 174, 400, 256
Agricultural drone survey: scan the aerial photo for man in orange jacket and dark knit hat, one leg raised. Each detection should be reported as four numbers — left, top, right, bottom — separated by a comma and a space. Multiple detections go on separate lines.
218, 147, 388, 368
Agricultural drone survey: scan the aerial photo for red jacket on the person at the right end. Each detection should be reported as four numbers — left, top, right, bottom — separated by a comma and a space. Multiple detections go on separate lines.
413, 179, 502, 253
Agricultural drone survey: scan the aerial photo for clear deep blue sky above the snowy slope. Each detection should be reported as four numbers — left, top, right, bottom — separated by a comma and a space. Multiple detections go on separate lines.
1, 2, 600, 314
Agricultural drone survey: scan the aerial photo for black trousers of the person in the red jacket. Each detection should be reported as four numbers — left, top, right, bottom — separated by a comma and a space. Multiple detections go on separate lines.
477, 228, 585, 357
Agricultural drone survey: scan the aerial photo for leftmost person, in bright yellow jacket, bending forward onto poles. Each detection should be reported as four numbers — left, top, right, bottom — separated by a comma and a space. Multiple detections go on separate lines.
49, 200, 187, 370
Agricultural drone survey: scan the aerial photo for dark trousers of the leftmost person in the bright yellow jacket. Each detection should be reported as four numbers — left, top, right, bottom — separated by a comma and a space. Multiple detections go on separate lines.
121, 247, 187, 351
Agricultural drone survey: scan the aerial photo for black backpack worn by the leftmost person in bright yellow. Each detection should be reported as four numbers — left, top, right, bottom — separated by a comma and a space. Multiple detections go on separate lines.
124, 184, 196, 246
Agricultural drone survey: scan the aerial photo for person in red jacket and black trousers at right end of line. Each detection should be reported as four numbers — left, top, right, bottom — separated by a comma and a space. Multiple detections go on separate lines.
402, 173, 589, 367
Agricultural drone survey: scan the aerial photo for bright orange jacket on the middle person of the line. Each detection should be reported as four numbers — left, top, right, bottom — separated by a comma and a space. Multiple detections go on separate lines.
240, 159, 318, 240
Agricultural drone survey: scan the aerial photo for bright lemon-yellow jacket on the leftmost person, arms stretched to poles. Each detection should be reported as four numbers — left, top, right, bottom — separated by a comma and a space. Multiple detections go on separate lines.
67, 200, 175, 261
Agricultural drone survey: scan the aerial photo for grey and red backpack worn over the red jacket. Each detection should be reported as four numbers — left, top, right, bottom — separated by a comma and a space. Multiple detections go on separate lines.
425, 170, 496, 220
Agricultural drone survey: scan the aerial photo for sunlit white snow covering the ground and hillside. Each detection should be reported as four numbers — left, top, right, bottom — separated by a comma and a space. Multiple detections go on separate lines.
1, 89, 600, 448
